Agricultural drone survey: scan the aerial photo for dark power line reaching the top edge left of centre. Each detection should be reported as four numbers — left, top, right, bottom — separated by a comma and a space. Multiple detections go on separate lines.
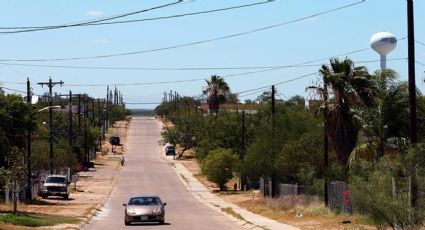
0, 0, 183, 34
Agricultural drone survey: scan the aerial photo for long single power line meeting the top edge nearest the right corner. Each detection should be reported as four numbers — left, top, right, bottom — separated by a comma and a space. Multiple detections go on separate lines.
0, 0, 365, 62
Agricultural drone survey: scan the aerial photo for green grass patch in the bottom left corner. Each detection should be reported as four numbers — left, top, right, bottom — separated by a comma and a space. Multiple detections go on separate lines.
0, 213, 80, 227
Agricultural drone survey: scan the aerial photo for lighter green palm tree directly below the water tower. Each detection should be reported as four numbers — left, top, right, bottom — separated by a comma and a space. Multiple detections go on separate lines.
350, 69, 408, 160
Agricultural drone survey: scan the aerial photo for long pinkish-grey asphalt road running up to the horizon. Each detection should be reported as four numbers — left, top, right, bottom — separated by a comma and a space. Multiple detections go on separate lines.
83, 117, 241, 230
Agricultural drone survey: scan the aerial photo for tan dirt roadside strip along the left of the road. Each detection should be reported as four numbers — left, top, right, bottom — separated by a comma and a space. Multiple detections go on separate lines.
0, 121, 127, 229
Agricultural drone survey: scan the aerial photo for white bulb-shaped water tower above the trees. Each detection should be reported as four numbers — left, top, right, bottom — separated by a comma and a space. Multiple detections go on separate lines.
370, 32, 397, 70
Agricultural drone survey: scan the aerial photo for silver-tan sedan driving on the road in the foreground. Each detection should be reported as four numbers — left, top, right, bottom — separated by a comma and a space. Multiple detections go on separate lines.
123, 195, 167, 225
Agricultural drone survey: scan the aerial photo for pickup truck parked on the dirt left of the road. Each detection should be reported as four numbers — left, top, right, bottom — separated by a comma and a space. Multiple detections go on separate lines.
41, 175, 70, 200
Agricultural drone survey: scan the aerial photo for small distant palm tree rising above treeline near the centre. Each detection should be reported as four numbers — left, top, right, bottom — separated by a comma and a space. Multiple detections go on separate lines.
202, 75, 230, 116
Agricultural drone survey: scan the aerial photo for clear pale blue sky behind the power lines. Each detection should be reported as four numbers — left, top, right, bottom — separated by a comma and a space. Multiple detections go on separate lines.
0, 0, 425, 108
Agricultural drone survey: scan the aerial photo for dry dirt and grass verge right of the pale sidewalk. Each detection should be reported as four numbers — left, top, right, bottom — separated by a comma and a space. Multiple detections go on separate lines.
180, 151, 375, 229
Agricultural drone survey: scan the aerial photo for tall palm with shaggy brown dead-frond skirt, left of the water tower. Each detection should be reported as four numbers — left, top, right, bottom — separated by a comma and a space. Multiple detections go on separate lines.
319, 58, 377, 172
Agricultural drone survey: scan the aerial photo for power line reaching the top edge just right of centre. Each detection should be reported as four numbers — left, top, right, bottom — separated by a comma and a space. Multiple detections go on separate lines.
0, 0, 275, 29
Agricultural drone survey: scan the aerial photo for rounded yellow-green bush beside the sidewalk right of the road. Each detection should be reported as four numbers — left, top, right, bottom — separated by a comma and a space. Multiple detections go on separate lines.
201, 149, 238, 191
